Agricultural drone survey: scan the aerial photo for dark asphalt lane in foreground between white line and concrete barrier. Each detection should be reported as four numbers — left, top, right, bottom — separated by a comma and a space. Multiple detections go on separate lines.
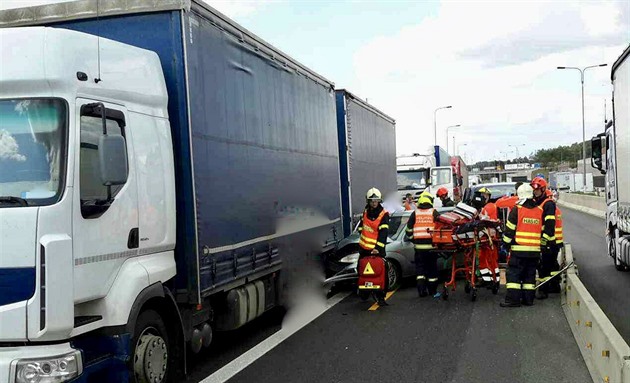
229, 287, 591, 383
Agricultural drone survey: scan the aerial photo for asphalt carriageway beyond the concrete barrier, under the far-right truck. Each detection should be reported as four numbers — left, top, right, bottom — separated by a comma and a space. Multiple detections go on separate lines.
562, 207, 630, 343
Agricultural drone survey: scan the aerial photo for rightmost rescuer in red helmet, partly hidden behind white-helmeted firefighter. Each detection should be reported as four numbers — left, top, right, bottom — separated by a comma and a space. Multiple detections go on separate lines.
537, 189, 564, 299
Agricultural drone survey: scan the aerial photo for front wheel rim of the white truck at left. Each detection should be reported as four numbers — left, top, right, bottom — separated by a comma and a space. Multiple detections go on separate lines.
134, 327, 168, 383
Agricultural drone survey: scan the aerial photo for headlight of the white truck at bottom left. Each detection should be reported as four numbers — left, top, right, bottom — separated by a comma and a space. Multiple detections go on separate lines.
14, 351, 83, 383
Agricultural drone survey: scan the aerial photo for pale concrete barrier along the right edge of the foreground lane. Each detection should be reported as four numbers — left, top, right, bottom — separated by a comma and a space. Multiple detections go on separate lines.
562, 244, 630, 383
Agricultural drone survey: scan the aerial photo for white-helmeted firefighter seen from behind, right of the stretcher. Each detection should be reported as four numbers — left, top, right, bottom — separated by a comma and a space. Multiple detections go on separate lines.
501, 184, 544, 307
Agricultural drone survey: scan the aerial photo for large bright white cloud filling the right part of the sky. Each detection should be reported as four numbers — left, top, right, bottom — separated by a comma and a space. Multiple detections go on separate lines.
349, 2, 630, 160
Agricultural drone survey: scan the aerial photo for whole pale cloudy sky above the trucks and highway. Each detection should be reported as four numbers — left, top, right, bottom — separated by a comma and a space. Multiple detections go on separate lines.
0, 0, 630, 163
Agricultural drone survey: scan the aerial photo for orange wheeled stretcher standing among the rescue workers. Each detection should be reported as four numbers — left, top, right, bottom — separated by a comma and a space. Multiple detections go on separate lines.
432, 207, 501, 301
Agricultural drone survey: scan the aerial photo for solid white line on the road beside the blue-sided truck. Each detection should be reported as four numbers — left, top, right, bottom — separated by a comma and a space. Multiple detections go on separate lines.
200, 292, 350, 383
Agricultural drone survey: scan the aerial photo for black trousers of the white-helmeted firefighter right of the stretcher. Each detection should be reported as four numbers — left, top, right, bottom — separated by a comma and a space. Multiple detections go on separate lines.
505, 252, 540, 304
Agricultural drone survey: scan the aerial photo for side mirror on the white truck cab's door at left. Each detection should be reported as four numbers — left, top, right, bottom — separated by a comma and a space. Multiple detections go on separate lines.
98, 134, 127, 186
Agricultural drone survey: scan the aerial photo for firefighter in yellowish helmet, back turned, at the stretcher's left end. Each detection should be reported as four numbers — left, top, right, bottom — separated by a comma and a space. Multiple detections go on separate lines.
406, 190, 438, 298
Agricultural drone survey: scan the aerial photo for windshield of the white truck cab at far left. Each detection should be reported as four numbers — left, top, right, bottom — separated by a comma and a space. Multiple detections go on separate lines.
0, 99, 67, 208
